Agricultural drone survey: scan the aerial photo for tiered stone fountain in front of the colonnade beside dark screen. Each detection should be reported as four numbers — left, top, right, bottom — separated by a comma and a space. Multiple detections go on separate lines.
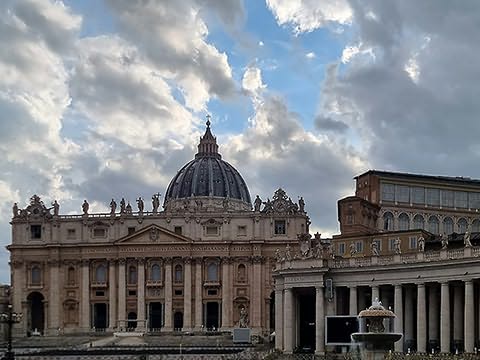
352, 299, 402, 360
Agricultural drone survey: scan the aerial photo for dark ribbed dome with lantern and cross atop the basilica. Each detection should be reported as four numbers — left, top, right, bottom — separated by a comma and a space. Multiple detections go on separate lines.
164, 121, 251, 208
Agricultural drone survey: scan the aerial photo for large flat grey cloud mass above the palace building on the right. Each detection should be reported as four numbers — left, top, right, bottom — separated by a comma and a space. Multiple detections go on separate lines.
320, 0, 480, 177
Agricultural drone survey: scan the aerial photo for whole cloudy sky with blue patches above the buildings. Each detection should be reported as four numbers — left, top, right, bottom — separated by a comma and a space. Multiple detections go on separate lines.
0, 0, 480, 283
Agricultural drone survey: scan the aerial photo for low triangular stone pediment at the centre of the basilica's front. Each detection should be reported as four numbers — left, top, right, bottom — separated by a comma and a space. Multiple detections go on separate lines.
115, 224, 192, 245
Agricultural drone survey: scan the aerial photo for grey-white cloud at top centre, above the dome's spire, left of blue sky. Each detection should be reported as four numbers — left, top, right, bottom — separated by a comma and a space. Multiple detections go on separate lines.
109, 0, 236, 111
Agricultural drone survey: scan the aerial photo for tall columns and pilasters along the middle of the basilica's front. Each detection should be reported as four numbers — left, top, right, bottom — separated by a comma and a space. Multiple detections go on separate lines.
74, 257, 266, 331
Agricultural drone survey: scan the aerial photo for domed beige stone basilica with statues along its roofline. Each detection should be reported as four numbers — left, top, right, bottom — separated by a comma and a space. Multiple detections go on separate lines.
8, 124, 309, 335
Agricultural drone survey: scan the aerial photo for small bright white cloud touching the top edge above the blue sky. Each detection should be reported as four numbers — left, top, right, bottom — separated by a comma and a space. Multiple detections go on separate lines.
267, 0, 352, 34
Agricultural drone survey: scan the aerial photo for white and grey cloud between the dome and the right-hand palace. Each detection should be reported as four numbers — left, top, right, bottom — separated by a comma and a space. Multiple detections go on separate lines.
222, 93, 365, 234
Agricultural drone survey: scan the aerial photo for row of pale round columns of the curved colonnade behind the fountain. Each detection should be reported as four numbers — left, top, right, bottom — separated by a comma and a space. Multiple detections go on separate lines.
275, 279, 480, 354
